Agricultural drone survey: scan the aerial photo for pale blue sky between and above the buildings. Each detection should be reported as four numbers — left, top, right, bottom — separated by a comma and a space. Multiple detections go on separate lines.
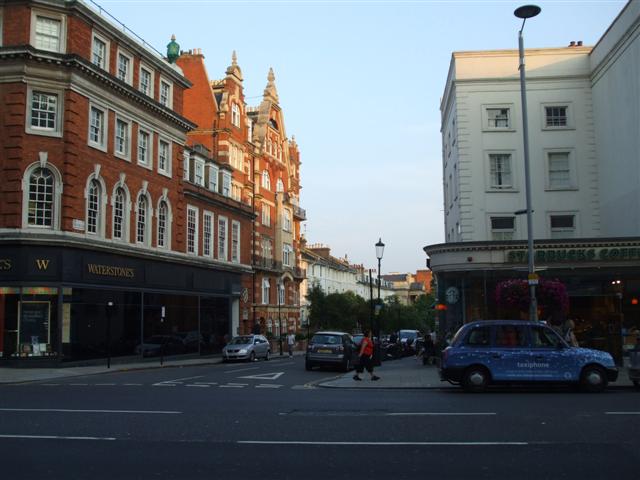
95, 0, 624, 274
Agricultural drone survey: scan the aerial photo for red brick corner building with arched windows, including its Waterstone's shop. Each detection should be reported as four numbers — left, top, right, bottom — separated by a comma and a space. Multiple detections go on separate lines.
0, 0, 254, 361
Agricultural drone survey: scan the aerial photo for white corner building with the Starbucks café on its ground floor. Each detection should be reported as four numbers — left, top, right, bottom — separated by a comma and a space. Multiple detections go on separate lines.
424, 0, 640, 359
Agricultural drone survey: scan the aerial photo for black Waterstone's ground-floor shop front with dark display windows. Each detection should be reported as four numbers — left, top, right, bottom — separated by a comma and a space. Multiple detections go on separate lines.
0, 245, 246, 366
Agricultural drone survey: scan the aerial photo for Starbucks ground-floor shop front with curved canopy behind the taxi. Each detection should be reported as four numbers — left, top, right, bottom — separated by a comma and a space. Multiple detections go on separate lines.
424, 238, 640, 362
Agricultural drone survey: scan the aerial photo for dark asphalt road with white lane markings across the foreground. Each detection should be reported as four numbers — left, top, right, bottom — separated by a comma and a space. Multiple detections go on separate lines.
0, 357, 640, 480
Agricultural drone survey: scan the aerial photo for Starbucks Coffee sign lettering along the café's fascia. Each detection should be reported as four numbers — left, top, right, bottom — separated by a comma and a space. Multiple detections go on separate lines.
507, 246, 640, 263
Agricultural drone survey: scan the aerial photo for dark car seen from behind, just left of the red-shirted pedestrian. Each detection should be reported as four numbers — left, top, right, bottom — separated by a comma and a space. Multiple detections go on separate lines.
304, 331, 358, 372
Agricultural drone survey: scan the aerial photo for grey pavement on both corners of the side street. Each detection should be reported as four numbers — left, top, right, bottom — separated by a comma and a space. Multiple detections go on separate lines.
0, 352, 633, 389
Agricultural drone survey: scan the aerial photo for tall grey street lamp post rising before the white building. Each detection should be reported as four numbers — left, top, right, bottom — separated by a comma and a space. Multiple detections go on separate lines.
513, 5, 540, 321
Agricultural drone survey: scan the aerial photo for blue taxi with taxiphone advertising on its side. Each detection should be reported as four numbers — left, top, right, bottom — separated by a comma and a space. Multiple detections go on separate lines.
440, 320, 618, 392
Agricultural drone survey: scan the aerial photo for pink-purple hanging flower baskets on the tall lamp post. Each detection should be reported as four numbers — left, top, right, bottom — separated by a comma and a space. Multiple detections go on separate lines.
496, 279, 569, 313
